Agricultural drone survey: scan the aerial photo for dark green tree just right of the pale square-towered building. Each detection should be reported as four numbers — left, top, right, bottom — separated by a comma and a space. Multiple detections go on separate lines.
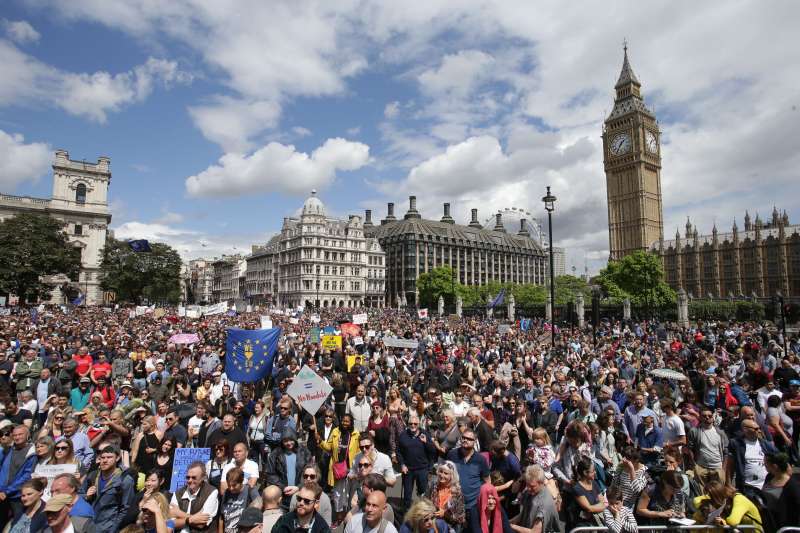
100, 238, 181, 304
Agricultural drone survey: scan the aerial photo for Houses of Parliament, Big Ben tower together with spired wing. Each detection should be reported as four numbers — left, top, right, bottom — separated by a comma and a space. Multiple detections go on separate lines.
603, 46, 800, 298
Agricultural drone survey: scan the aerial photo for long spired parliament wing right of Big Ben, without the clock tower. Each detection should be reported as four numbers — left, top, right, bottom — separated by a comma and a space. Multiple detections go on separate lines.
652, 209, 800, 298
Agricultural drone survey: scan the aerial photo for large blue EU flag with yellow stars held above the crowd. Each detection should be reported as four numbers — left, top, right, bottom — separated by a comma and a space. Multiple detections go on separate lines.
225, 328, 281, 383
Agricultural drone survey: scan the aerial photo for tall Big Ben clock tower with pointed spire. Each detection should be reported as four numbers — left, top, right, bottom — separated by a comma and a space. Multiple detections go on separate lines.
603, 44, 664, 260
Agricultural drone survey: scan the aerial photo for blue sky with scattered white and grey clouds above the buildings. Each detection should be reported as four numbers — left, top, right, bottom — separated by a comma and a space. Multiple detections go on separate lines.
0, 0, 800, 271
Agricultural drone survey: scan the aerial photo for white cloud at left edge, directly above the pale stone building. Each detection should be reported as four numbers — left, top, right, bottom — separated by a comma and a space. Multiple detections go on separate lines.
0, 130, 53, 191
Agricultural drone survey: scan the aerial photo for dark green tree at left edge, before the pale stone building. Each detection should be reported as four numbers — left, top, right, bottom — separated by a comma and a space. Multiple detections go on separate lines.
0, 213, 81, 302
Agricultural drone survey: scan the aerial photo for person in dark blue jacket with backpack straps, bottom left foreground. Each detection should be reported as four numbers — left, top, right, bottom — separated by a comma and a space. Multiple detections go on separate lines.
81, 445, 134, 533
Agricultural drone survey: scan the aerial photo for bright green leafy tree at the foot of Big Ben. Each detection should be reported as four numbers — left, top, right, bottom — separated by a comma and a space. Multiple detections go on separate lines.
597, 251, 676, 307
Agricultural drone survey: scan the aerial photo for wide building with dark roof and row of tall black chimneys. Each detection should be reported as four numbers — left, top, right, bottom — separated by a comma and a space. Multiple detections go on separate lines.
364, 196, 548, 306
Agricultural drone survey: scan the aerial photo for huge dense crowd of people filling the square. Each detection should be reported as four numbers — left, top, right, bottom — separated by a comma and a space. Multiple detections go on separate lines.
0, 307, 800, 533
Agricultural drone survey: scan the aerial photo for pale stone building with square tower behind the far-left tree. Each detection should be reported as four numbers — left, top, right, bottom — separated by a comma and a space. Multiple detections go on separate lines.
0, 150, 111, 305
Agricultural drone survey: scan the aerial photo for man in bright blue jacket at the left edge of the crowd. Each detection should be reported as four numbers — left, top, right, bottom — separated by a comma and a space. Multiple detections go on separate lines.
0, 424, 36, 521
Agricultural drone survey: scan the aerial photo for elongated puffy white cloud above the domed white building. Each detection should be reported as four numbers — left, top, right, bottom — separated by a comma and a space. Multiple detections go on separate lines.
186, 137, 369, 196
